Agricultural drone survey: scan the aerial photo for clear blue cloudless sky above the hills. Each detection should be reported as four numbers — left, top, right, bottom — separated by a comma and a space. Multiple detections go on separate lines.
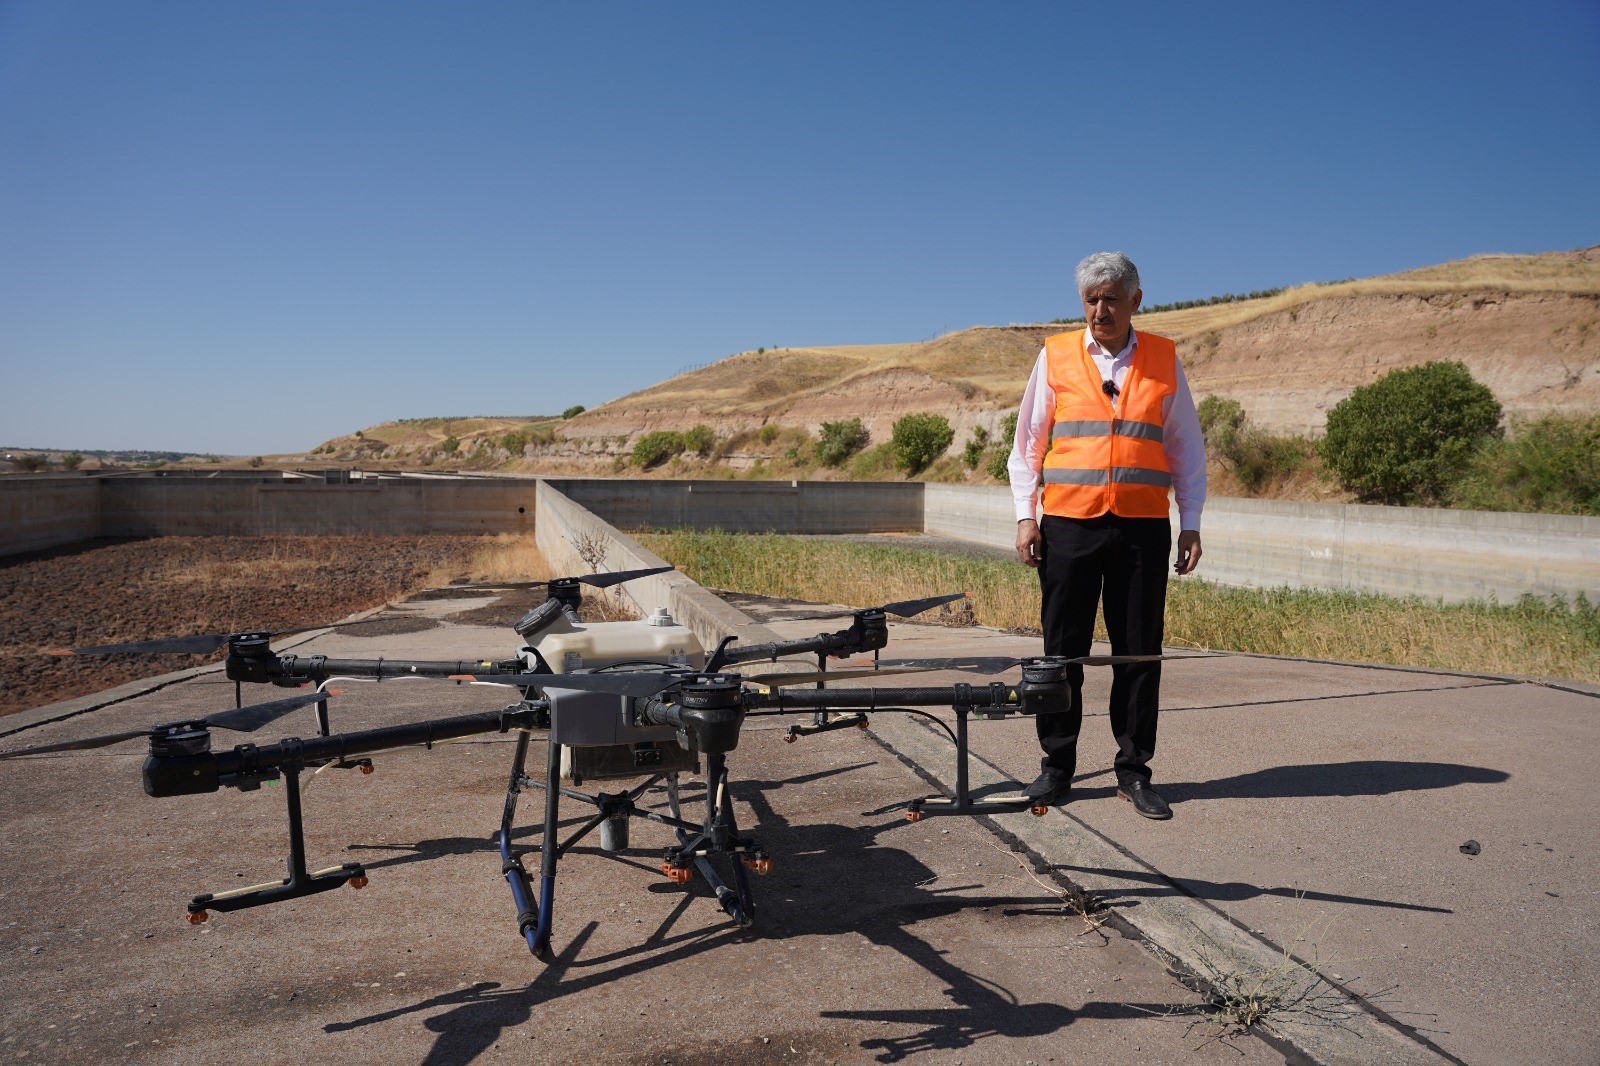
0, 0, 1600, 455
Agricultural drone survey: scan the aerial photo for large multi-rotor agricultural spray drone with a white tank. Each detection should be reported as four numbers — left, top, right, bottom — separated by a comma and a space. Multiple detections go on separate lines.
0, 567, 1163, 960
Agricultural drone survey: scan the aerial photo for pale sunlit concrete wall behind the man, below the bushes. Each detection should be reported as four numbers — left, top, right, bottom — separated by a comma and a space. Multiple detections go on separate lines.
923, 485, 1600, 603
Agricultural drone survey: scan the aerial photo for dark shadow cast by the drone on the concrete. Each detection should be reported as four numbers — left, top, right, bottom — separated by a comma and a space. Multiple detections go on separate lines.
325, 763, 1176, 1066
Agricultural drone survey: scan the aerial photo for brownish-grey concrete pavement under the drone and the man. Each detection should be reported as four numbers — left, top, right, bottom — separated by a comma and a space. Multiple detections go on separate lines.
0, 589, 1600, 1063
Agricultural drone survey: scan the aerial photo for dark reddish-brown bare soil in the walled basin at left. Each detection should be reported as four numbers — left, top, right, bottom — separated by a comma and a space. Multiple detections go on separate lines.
0, 536, 492, 714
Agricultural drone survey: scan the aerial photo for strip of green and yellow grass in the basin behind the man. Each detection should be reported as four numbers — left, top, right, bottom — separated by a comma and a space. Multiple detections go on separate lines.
640, 531, 1600, 683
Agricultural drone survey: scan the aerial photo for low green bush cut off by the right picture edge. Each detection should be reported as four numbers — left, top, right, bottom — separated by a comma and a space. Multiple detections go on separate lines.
1452, 415, 1600, 515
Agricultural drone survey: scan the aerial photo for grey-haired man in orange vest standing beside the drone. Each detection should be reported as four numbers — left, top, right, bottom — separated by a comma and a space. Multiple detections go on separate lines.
1010, 251, 1206, 818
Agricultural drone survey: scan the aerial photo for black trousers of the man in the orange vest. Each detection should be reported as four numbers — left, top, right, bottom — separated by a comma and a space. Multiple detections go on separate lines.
1034, 514, 1173, 784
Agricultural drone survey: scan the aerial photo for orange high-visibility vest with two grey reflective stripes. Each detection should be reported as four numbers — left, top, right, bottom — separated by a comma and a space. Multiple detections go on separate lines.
1040, 330, 1178, 519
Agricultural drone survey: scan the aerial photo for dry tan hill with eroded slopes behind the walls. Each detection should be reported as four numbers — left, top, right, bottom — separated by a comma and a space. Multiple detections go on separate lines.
315, 245, 1600, 466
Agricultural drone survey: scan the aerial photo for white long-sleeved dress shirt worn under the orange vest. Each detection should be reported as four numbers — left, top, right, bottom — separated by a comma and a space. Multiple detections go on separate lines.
1006, 330, 1206, 533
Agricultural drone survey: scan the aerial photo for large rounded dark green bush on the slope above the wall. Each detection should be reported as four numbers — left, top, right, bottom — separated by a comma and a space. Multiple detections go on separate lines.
1320, 360, 1501, 503
